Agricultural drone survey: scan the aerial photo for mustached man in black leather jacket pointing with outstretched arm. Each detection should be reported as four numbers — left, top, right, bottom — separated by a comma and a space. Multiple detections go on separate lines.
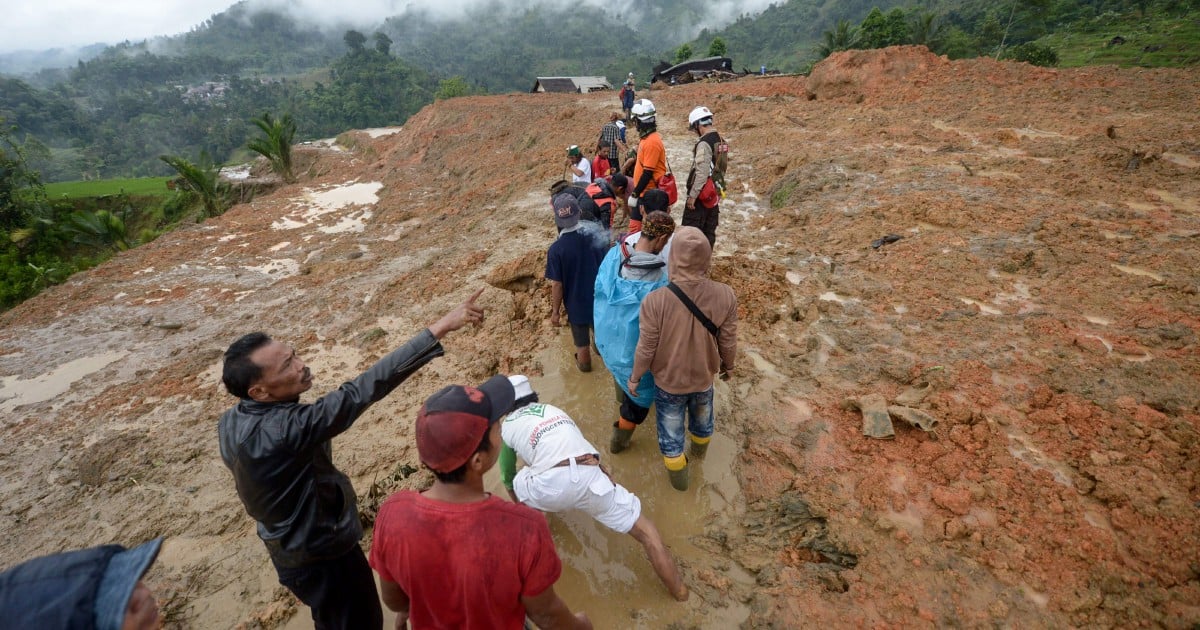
217, 289, 484, 630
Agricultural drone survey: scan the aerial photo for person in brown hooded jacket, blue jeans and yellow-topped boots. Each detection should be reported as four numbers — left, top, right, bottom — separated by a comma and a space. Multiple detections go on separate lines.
626, 226, 738, 491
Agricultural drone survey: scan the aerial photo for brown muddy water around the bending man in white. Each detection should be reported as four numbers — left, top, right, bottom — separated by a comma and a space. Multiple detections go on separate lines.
487, 326, 752, 629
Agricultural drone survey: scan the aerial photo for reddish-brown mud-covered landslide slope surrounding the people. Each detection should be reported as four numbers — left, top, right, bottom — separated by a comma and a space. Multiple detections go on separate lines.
0, 48, 1200, 628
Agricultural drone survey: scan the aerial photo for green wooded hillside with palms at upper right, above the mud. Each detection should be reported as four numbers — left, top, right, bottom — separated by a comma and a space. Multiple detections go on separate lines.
684, 0, 1200, 72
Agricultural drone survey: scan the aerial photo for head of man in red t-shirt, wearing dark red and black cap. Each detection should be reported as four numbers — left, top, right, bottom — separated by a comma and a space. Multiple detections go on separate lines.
416, 374, 514, 484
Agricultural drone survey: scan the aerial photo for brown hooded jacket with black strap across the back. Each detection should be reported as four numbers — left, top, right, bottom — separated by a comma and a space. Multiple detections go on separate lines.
631, 227, 738, 395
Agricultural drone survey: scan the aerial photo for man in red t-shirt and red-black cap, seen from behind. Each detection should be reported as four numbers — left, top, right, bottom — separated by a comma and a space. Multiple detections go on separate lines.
371, 374, 592, 630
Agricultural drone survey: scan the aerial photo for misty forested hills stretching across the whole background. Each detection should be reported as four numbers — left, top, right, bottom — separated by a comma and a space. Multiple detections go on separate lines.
0, 0, 1200, 181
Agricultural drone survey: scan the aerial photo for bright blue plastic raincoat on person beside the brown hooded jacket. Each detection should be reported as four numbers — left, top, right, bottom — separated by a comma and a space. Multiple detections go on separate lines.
592, 244, 667, 408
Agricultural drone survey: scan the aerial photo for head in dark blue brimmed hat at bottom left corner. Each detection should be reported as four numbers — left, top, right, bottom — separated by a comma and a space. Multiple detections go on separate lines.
0, 538, 162, 630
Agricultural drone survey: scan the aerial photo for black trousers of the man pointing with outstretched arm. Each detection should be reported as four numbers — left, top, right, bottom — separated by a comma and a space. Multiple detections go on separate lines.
275, 545, 383, 630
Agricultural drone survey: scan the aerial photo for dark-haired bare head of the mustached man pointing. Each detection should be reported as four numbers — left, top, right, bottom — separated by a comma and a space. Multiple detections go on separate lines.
221, 332, 312, 402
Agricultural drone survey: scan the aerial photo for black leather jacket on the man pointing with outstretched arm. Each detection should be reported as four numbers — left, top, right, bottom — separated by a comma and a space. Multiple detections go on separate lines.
217, 329, 444, 568
